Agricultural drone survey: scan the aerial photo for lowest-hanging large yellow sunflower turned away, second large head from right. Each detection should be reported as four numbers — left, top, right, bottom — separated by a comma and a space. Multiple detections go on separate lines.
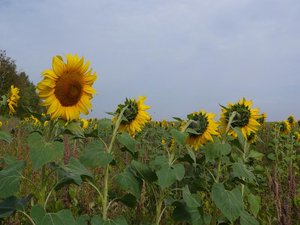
185, 111, 219, 150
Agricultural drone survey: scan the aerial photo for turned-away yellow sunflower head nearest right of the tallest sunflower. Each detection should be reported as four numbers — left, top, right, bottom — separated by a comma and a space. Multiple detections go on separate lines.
113, 96, 151, 136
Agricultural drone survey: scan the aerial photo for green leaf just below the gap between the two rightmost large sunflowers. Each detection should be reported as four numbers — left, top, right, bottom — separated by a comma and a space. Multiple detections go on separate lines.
203, 139, 231, 162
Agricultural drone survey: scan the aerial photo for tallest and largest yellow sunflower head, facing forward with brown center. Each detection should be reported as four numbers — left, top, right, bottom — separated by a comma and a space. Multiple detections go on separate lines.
37, 54, 97, 121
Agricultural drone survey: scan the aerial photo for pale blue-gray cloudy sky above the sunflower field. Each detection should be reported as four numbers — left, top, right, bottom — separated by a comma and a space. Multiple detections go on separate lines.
0, 0, 300, 121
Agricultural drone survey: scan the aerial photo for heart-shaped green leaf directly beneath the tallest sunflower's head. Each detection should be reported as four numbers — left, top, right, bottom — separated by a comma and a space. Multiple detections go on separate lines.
27, 133, 64, 170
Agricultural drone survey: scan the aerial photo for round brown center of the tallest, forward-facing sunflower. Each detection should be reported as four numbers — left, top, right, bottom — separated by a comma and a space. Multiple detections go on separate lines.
54, 73, 82, 106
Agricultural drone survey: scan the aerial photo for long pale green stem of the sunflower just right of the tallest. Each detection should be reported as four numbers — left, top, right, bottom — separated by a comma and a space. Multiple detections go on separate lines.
102, 106, 127, 220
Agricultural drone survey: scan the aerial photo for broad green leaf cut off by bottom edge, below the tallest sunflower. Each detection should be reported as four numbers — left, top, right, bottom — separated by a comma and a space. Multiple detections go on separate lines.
31, 206, 78, 225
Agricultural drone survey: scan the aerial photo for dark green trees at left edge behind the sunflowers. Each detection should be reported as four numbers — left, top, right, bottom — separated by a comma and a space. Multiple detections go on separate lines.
0, 50, 42, 117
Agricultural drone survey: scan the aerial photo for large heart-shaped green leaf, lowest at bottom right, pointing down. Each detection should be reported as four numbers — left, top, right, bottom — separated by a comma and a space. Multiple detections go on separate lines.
211, 183, 244, 223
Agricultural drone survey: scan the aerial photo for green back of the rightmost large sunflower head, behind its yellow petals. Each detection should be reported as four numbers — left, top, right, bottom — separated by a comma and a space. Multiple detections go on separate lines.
225, 104, 251, 127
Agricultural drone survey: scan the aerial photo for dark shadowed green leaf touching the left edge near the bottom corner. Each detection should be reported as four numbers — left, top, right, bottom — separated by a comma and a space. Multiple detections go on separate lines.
0, 194, 32, 218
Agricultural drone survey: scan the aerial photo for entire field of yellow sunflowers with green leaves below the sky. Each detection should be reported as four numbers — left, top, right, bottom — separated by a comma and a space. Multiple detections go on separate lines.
0, 54, 300, 225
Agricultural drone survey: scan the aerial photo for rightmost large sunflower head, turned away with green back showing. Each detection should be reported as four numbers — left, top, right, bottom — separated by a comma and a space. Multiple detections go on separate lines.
220, 98, 261, 139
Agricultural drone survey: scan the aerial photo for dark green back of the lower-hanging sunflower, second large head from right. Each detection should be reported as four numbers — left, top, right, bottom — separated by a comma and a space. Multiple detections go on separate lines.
187, 113, 208, 136
